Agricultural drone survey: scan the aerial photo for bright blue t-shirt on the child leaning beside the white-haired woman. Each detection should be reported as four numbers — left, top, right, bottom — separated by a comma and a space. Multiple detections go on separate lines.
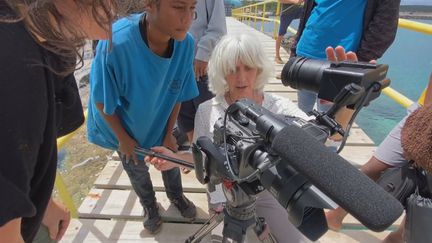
87, 14, 198, 150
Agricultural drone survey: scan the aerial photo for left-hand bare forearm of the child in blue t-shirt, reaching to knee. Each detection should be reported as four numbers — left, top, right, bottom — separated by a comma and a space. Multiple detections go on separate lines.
96, 103, 138, 163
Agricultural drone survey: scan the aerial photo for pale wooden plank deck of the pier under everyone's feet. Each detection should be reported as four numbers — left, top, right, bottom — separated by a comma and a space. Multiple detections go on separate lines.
62, 18, 394, 243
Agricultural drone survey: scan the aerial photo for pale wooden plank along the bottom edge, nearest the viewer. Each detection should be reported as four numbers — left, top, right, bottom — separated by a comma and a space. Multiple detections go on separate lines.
60, 219, 389, 243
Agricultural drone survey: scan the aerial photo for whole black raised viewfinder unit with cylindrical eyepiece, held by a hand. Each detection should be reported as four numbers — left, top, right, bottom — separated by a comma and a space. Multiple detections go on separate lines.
281, 57, 390, 109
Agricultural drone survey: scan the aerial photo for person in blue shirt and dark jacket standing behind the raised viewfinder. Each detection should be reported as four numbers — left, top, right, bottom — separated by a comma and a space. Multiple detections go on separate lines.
291, 0, 400, 146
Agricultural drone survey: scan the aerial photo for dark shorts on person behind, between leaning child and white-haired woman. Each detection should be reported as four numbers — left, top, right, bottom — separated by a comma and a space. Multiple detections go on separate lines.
177, 75, 214, 133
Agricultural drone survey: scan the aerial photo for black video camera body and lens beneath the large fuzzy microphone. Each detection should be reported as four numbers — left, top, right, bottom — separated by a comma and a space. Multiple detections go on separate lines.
193, 99, 332, 240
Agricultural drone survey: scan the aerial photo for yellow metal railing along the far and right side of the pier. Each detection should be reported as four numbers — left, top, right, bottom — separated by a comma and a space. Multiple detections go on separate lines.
232, 0, 432, 108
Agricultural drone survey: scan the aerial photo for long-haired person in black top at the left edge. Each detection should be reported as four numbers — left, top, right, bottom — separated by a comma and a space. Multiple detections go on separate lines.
0, 0, 130, 242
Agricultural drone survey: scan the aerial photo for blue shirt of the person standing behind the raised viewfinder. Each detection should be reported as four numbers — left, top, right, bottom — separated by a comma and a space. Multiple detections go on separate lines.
297, 0, 367, 59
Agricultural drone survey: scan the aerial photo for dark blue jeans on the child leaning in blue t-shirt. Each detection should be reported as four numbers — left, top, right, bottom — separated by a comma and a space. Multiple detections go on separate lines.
117, 152, 183, 208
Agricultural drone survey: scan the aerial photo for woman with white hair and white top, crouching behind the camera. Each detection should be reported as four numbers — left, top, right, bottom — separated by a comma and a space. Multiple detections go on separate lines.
146, 35, 308, 242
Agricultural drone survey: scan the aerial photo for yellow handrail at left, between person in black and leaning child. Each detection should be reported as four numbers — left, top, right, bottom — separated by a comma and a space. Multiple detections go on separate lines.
54, 111, 87, 218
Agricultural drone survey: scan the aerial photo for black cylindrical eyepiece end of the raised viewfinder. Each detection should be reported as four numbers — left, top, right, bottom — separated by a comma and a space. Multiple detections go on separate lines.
281, 57, 331, 92
